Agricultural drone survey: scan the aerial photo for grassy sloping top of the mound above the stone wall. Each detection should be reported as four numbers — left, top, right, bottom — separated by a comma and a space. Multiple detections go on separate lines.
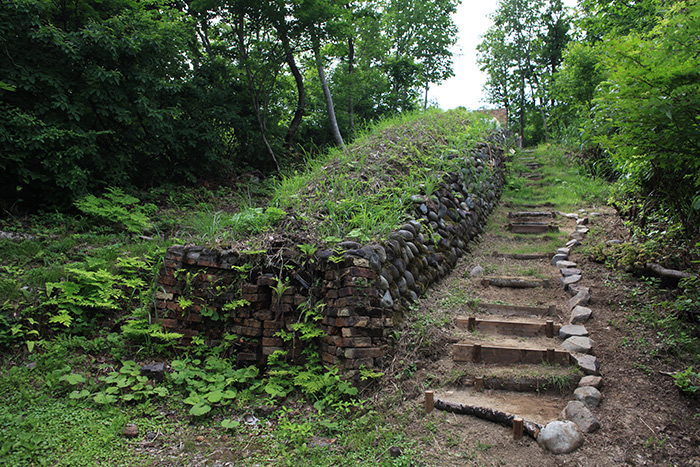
272, 111, 498, 247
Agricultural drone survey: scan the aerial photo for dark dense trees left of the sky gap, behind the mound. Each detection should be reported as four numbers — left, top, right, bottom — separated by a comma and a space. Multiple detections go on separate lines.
0, 0, 458, 209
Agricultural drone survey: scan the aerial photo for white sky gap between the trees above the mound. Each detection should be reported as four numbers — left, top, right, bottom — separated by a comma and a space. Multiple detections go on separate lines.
428, 0, 576, 110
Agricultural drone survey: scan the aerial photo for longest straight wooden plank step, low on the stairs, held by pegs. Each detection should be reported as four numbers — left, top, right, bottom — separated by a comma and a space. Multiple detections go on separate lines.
452, 344, 571, 365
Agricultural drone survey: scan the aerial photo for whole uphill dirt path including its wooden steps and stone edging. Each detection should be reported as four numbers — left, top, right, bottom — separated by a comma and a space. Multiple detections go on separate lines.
394, 153, 700, 466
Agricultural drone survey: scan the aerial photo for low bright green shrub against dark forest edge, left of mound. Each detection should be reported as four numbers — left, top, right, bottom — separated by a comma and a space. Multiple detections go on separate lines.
75, 187, 155, 234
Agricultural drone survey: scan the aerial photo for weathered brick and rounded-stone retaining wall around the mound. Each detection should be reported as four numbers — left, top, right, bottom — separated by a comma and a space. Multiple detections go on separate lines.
156, 144, 504, 373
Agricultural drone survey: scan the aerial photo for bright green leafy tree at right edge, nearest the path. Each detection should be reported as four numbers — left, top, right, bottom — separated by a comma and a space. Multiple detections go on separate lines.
595, 1, 700, 232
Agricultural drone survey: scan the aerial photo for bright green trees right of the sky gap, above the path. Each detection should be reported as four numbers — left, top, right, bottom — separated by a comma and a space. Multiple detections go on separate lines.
479, 0, 700, 237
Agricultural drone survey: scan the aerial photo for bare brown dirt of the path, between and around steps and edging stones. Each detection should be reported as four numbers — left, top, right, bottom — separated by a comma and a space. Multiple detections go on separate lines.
400, 152, 700, 466
